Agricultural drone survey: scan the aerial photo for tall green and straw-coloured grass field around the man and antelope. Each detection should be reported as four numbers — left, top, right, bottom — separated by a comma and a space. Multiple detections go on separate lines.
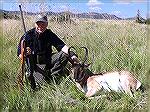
0, 18, 149, 112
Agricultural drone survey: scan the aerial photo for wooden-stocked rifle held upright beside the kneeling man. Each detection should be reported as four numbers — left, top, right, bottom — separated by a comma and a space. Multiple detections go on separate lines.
18, 5, 26, 89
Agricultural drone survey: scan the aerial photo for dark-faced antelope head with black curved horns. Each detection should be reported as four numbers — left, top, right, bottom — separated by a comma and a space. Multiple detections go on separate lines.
68, 47, 89, 82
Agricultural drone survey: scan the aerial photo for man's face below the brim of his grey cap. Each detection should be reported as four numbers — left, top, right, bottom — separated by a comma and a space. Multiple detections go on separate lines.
35, 21, 48, 33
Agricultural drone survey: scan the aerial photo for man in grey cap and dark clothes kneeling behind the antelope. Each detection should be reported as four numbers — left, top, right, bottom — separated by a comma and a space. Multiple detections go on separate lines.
17, 15, 77, 90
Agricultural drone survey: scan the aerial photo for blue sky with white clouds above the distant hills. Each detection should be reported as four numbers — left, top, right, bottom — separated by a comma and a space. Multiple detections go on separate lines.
0, 0, 150, 18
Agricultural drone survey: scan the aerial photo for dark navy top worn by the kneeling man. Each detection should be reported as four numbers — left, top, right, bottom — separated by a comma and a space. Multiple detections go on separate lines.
17, 28, 65, 65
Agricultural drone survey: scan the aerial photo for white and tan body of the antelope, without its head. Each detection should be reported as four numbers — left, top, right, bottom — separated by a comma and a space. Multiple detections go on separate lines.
76, 71, 141, 97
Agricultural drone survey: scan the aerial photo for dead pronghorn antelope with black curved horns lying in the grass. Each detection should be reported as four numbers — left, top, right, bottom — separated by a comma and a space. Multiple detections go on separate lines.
68, 47, 143, 97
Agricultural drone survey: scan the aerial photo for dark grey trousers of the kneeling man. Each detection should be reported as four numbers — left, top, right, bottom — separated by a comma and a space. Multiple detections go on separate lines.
26, 51, 69, 90
